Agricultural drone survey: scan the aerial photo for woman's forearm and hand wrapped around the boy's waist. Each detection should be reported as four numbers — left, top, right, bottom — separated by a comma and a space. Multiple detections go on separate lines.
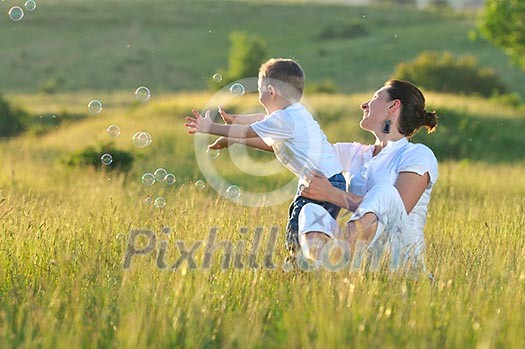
300, 173, 363, 211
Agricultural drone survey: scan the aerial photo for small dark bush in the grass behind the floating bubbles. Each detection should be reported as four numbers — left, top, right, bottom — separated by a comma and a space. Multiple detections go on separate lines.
62, 143, 134, 172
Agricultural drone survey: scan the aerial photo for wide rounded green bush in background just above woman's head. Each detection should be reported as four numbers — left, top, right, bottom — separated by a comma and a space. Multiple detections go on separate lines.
392, 51, 506, 97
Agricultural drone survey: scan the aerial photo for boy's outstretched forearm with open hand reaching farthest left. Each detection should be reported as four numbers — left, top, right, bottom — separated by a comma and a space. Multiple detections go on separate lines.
184, 109, 258, 139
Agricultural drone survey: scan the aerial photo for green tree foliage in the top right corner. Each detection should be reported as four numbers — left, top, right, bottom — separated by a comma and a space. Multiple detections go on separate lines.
479, 0, 525, 69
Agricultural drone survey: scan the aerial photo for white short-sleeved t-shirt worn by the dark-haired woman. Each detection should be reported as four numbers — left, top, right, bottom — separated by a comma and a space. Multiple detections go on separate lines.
333, 138, 438, 235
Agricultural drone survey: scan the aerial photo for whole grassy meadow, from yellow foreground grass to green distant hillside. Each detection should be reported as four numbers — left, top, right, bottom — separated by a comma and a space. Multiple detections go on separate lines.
0, 0, 525, 348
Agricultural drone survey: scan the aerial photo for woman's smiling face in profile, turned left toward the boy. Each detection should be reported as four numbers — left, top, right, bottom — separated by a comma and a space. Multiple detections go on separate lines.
359, 87, 391, 133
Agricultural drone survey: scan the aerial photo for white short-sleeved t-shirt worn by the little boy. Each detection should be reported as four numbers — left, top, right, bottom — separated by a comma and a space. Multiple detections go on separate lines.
251, 103, 342, 178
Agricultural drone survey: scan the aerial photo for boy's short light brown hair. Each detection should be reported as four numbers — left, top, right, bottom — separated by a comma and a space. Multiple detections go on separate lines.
259, 58, 304, 102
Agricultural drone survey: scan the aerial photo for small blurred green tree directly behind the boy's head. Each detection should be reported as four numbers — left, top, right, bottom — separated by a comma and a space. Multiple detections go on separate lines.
209, 32, 268, 89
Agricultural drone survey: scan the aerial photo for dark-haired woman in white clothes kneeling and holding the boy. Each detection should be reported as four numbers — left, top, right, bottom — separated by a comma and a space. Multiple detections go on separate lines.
299, 80, 438, 268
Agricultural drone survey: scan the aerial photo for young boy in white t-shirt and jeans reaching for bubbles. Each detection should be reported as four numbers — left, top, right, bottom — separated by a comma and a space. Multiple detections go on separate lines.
185, 58, 346, 255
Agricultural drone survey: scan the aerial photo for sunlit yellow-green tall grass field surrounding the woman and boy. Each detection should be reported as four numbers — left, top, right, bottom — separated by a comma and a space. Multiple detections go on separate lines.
0, 93, 525, 348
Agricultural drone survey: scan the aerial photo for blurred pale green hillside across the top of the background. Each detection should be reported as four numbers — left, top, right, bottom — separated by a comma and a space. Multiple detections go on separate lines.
0, 0, 525, 96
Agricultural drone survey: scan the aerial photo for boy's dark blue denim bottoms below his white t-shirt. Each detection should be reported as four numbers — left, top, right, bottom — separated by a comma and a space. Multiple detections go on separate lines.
286, 173, 346, 253
